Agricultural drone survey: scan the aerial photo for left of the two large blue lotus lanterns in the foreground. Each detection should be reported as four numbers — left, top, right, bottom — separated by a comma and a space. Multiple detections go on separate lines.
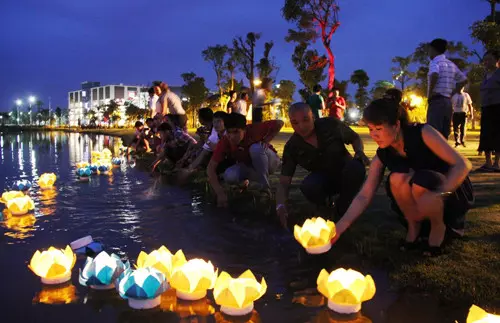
79, 251, 130, 289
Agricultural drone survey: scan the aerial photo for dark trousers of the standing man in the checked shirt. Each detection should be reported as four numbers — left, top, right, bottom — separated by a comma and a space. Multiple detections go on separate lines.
427, 96, 453, 140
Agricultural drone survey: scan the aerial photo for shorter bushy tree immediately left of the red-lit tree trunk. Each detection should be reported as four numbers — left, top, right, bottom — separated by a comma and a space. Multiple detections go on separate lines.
292, 43, 327, 100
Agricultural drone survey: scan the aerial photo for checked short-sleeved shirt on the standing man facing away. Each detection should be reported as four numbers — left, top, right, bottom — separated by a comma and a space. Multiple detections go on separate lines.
427, 54, 467, 98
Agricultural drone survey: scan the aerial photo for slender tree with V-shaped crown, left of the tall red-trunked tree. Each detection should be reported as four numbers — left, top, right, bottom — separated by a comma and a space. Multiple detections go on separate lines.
233, 32, 261, 93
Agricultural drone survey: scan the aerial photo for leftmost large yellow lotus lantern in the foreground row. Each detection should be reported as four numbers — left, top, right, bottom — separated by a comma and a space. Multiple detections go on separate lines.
29, 246, 76, 285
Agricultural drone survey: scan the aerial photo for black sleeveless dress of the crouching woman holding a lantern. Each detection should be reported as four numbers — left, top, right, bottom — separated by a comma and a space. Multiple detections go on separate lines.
377, 124, 474, 230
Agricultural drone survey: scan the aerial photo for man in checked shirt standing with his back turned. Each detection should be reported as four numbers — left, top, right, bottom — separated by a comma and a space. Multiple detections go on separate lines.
427, 38, 467, 139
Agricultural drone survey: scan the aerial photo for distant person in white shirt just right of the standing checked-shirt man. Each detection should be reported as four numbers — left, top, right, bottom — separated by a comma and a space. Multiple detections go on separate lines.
451, 88, 474, 148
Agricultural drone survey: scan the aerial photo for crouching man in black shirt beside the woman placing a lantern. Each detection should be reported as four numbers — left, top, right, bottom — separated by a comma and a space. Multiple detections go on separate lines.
276, 103, 370, 226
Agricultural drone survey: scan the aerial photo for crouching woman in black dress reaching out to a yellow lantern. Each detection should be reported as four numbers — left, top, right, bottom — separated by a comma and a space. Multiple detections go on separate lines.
333, 99, 473, 255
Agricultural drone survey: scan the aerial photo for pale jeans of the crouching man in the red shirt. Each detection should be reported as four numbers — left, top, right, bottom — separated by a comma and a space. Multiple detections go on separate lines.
223, 142, 281, 189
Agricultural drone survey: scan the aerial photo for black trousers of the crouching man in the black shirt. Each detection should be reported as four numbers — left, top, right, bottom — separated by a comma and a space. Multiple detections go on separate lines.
300, 159, 366, 216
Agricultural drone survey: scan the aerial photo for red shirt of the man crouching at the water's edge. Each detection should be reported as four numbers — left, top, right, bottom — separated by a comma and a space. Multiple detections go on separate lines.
212, 120, 279, 166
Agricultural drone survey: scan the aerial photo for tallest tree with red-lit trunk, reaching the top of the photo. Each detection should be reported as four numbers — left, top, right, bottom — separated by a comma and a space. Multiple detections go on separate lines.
282, 0, 340, 96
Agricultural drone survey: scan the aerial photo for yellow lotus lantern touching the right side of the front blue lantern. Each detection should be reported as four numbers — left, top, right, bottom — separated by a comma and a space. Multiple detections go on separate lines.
169, 259, 218, 301
